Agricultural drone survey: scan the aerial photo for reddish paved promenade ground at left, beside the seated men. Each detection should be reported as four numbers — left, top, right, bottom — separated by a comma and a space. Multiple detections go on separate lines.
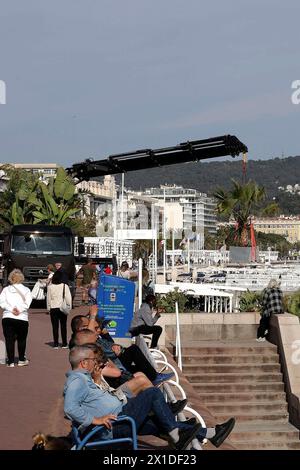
0, 307, 88, 450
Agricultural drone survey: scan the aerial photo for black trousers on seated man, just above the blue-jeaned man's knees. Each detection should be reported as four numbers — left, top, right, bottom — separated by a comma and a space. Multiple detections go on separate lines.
118, 344, 157, 382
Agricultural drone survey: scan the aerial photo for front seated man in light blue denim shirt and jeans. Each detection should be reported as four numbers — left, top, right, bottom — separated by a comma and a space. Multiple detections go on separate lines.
64, 346, 235, 450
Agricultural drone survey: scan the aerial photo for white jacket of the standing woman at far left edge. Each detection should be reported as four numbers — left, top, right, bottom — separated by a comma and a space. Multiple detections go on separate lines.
0, 284, 32, 321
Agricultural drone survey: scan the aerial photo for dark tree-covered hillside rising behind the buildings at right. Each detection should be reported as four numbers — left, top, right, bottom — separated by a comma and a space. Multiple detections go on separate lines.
118, 156, 300, 214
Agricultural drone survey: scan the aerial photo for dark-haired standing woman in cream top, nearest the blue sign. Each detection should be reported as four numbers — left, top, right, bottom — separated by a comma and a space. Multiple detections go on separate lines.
47, 271, 72, 349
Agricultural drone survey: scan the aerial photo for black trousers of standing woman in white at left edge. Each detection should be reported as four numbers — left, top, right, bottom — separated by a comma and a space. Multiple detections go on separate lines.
2, 318, 28, 364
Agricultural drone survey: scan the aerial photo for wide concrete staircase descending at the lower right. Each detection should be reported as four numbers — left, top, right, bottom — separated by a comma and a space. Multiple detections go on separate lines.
182, 340, 300, 450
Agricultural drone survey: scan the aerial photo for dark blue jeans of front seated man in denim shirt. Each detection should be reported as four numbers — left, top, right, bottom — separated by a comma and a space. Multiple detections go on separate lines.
114, 387, 206, 441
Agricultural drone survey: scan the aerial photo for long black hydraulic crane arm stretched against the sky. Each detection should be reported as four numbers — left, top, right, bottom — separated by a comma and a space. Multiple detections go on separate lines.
67, 135, 248, 181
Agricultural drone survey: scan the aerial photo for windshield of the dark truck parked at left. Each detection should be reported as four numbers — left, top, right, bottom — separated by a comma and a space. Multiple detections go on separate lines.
11, 233, 72, 255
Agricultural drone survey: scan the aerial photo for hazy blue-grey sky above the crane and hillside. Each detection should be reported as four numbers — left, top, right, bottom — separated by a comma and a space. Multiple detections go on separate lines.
0, 0, 300, 166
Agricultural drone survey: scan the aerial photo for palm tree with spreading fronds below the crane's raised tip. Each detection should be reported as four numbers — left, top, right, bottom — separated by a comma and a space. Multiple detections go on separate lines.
214, 180, 265, 246
